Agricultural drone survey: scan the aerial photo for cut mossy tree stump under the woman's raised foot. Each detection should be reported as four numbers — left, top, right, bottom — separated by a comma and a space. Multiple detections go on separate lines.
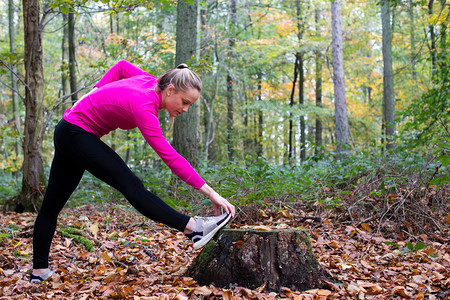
186, 229, 324, 292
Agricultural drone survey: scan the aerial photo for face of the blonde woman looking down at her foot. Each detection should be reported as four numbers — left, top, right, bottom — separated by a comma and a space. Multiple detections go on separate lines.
161, 84, 200, 117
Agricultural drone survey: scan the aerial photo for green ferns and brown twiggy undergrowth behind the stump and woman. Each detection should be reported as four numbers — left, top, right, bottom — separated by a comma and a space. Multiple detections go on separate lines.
0, 147, 450, 239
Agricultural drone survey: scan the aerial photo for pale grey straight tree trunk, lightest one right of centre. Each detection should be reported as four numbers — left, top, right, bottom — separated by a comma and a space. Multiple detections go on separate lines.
331, 0, 349, 155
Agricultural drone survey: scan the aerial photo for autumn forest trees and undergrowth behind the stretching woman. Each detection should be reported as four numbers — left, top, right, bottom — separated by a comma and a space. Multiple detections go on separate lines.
0, 0, 450, 298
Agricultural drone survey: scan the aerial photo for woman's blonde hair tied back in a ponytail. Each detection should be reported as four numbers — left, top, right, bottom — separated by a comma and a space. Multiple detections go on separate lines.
158, 64, 202, 92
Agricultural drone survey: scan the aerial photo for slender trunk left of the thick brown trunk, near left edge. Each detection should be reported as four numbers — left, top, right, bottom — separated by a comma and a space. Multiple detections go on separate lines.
8, 0, 22, 157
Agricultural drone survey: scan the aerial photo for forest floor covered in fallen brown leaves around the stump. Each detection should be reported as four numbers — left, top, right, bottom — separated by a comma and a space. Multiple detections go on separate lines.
0, 196, 450, 300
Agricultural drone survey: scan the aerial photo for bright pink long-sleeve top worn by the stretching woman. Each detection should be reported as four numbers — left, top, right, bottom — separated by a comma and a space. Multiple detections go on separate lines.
64, 60, 205, 189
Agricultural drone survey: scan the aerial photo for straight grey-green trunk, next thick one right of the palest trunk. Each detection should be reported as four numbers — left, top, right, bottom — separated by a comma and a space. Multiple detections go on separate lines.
381, 0, 395, 149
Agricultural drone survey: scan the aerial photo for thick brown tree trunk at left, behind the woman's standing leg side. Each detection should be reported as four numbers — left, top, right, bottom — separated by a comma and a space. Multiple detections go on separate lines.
15, 0, 44, 212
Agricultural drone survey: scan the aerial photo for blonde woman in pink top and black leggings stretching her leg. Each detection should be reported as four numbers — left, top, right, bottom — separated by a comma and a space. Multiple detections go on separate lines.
30, 61, 235, 282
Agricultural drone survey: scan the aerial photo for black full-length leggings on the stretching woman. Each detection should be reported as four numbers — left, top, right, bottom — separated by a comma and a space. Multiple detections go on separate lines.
33, 120, 190, 269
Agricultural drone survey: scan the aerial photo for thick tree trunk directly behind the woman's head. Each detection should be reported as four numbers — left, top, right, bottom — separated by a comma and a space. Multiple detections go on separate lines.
173, 0, 199, 166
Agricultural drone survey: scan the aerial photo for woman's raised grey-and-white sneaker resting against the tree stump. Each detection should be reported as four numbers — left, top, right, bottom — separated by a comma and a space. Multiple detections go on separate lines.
186, 213, 231, 250
